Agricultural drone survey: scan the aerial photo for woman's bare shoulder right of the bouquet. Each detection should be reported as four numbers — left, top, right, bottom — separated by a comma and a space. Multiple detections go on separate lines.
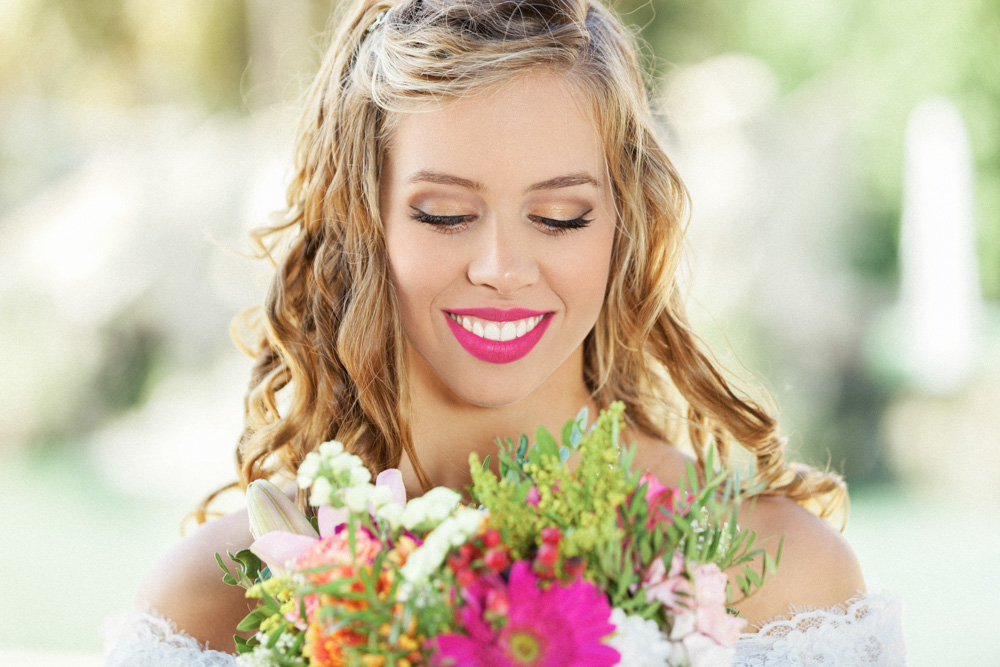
729, 497, 865, 631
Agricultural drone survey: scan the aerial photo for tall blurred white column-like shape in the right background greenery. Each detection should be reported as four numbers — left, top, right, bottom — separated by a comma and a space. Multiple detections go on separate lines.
899, 98, 982, 394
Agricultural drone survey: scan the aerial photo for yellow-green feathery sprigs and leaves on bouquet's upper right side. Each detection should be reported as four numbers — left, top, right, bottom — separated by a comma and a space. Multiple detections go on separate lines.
470, 403, 778, 618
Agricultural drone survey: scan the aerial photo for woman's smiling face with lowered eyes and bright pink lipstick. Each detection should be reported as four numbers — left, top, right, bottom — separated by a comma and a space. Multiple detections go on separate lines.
381, 73, 615, 406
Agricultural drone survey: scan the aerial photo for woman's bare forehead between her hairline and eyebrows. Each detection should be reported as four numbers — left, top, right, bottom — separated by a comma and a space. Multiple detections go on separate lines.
386, 72, 606, 187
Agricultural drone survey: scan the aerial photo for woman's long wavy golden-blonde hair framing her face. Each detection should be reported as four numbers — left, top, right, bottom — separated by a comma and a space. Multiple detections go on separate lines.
201, 0, 846, 518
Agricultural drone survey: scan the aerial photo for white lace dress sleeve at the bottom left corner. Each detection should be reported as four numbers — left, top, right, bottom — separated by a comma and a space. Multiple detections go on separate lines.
102, 609, 236, 667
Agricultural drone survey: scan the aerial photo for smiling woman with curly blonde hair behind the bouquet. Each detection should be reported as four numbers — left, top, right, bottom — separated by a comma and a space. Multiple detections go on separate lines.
103, 0, 902, 665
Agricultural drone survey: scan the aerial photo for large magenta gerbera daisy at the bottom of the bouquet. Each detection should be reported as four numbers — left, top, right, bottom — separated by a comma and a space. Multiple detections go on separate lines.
437, 561, 621, 667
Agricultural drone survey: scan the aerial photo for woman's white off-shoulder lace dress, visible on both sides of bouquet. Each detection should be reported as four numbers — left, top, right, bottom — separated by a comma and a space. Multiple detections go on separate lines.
105, 593, 906, 667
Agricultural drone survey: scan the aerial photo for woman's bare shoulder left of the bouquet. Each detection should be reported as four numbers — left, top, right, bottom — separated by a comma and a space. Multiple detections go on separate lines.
136, 510, 253, 653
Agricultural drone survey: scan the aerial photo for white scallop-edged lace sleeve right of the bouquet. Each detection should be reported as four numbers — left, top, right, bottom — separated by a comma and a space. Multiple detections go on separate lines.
734, 592, 906, 667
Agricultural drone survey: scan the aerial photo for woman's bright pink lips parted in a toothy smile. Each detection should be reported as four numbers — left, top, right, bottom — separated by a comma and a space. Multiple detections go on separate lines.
444, 308, 552, 364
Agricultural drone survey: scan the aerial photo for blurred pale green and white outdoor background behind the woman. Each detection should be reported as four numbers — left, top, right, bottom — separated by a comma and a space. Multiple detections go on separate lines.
0, 0, 1000, 665
